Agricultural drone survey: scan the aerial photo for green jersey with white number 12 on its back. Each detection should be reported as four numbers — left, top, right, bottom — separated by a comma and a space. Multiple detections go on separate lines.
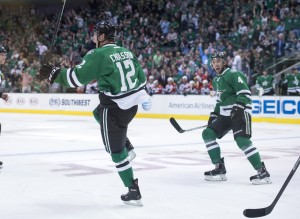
55, 44, 149, 109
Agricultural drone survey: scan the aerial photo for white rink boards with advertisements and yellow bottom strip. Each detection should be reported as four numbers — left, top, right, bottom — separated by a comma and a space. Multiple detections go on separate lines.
0, 93, 300, 124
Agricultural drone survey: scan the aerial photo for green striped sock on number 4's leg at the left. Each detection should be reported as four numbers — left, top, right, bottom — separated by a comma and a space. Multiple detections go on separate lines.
202, 128, 221, 164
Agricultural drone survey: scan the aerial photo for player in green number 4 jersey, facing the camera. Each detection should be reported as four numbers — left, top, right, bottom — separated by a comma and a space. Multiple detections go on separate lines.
202, 52, 271, 184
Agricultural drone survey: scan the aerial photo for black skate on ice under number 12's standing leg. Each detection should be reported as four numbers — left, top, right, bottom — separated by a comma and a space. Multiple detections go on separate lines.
121, 179, 143, 207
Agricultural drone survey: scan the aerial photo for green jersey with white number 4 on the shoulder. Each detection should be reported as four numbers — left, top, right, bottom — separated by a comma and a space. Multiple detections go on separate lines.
213, 68, 252, 116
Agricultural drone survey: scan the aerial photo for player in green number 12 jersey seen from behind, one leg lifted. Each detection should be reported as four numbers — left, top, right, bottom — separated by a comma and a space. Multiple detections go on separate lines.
40, 20, 151, 206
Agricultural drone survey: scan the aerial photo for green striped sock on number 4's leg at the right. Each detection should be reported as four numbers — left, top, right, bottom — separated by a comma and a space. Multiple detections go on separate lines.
235, 137, 262, 170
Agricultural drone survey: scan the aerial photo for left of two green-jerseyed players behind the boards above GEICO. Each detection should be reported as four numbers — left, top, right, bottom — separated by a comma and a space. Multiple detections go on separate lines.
256, 71, 275, 96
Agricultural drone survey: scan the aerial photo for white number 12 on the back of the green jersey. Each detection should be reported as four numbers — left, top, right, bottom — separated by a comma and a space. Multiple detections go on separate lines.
116, 59, 137, 91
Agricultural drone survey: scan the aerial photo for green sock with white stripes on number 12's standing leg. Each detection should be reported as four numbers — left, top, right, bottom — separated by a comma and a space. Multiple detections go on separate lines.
111, 148, 133, 187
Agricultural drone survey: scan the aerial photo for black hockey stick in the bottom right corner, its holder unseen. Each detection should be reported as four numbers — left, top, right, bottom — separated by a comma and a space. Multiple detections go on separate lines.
243, 156, 300, 218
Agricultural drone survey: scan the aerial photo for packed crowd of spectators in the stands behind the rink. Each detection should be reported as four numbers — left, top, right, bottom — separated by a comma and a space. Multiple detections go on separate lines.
0, 0, 300, 95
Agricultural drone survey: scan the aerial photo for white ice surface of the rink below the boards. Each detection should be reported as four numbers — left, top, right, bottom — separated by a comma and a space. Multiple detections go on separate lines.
0, 113, 300, 219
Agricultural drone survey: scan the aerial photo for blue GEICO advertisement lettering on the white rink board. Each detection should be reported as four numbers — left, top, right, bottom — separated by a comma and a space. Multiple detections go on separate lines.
252, 100, 300, 115
